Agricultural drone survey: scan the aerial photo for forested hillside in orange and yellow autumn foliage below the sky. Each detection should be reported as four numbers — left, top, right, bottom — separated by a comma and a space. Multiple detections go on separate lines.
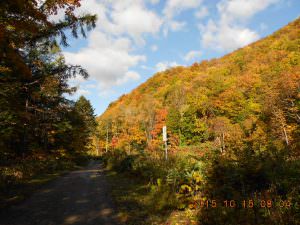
98, 19, 300, 155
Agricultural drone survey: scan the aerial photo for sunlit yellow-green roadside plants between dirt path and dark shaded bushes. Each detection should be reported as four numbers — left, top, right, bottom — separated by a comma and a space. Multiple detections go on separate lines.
102, 151, 200, 224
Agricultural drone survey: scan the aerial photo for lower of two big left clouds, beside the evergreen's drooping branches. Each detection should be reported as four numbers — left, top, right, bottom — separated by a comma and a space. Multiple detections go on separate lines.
64, 31, 146, 87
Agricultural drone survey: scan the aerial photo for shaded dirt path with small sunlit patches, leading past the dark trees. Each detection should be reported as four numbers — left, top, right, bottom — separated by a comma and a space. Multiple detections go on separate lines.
0, 162, 118, 225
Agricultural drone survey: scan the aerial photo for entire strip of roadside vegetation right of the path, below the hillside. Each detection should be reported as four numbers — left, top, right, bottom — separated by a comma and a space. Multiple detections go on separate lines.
103, 145, 300, 224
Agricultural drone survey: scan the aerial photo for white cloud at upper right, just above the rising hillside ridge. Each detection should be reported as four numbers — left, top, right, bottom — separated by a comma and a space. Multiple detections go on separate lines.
199, 0, 279, 52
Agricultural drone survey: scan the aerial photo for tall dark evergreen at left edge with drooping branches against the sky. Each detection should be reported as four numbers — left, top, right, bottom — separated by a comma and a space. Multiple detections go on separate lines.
0, 0, 96, 156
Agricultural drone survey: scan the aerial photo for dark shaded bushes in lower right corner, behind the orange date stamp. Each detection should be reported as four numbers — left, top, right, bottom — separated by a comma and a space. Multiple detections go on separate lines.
199, 149, 300, 225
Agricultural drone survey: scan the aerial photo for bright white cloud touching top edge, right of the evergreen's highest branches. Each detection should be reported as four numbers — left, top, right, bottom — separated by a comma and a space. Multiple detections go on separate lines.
77, 0, 163, 43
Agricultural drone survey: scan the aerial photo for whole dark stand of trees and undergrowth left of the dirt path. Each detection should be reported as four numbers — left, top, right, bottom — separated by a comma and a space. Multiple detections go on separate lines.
0, 0, 96, 203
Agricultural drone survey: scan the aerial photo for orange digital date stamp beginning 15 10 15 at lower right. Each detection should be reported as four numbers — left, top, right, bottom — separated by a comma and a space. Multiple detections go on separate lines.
194, 199, 298, 209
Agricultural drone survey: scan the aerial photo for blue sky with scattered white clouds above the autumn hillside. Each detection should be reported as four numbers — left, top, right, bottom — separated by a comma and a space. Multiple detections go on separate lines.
55, 0, 300, 115
